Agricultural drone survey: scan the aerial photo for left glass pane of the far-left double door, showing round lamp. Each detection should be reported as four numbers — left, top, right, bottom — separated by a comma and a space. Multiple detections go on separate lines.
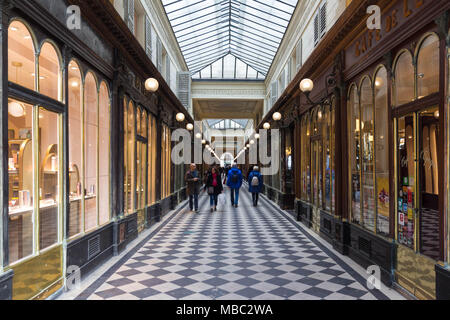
8, 99, 34, 263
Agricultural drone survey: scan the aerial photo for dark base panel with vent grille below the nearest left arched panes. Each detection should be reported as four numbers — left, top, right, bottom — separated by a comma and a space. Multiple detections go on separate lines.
66, 223, 114, 279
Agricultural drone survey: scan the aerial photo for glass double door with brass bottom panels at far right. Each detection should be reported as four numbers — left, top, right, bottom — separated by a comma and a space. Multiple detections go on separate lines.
396, 107, 440, 298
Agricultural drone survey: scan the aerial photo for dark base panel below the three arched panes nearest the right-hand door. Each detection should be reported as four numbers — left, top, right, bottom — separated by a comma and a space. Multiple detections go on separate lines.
348, 224, 397, 286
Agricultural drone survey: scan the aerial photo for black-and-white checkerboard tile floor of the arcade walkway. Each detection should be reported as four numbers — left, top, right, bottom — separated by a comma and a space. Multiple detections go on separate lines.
77, 188, 387, 300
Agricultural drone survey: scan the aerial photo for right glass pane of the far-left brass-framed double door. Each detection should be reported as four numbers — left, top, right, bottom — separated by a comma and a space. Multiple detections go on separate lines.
39, 108, 61, 250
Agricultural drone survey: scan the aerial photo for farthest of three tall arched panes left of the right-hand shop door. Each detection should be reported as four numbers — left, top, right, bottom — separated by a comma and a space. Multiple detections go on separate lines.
347, 85, 361, 223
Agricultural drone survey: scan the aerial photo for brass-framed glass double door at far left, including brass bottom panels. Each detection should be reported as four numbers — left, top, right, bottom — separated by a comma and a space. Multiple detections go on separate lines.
8, 103, 64, 300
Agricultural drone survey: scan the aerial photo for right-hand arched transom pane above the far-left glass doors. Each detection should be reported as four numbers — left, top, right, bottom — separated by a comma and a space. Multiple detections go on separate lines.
39, 42, 62, 100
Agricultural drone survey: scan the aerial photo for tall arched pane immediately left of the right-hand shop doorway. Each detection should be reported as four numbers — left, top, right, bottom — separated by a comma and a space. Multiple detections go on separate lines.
374, 67, 390, 235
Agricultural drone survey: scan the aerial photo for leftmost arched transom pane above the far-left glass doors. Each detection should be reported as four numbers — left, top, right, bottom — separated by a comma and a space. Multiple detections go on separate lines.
8, 20, 36, 90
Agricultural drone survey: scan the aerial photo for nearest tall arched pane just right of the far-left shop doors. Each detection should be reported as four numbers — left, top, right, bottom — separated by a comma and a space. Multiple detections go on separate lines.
68, 61, 84, 237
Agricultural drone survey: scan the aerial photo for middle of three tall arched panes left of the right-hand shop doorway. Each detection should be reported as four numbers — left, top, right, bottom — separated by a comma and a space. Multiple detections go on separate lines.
360, 77, 375, 230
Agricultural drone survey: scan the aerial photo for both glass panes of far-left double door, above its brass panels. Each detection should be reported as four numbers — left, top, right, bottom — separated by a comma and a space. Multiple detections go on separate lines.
8, 99, 62, 263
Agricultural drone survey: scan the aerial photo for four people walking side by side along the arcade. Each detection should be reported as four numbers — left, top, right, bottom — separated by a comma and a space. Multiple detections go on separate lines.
185, 163, 263, 212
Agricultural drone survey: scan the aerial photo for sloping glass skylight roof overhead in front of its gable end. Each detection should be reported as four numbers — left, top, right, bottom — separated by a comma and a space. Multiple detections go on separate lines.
162, 0, 298, 76
